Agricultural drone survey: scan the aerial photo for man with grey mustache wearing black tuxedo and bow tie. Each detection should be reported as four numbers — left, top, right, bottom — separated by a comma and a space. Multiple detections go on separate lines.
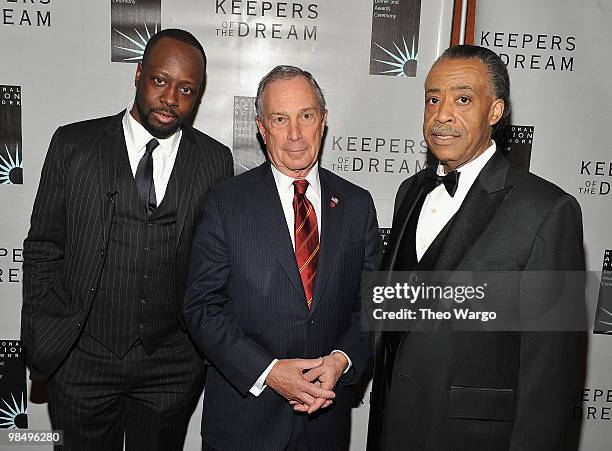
368, 46, 585, 451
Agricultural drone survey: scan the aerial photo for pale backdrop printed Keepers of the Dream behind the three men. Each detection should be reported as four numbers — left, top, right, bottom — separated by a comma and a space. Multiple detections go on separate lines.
0, 0, 612, 451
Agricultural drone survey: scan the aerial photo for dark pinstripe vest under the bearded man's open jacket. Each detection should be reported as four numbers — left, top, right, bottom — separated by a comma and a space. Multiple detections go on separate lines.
85, 143, 180, 357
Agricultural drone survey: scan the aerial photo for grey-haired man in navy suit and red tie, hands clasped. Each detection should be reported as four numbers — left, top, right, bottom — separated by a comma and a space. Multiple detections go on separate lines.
184, 66, 380, 451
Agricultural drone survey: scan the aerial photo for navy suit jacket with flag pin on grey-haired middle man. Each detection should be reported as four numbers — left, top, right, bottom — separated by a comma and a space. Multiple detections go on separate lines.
184, 162, 380, 451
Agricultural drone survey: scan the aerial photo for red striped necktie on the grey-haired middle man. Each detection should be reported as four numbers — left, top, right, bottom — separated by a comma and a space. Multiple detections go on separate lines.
293, 179, 319, 309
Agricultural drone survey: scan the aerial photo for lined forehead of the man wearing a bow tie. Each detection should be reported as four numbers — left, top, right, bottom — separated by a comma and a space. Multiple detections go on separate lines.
425, 58, 490, 92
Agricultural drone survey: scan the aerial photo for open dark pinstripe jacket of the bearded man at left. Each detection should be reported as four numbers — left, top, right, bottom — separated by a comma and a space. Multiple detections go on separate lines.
21, 112, 233, 379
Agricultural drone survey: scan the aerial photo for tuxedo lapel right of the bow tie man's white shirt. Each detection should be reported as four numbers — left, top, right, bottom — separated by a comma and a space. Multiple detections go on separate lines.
435, 151, 512, 271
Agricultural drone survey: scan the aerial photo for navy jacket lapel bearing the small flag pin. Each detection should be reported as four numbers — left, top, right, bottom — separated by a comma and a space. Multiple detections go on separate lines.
310, 169, 344, 315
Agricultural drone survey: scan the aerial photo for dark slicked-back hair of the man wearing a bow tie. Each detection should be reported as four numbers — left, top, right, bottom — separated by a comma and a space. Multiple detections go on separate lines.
434, 45, 511, 137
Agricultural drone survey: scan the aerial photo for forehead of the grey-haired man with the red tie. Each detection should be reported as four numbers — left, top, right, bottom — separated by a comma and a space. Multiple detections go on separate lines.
263, 75, 319, 113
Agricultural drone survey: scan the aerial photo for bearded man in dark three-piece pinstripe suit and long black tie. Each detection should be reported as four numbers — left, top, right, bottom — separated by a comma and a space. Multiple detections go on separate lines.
22, 29, 233, 451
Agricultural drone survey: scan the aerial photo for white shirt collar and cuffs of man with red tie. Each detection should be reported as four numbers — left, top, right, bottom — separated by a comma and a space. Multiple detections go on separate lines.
249, 163, 351, 396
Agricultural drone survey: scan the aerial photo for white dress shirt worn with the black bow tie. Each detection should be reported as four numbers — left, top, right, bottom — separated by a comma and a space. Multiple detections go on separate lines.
415, 142, 495, 261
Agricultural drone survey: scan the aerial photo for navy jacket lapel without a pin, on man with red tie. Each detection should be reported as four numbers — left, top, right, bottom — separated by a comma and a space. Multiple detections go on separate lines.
246, 161, 306, 300
